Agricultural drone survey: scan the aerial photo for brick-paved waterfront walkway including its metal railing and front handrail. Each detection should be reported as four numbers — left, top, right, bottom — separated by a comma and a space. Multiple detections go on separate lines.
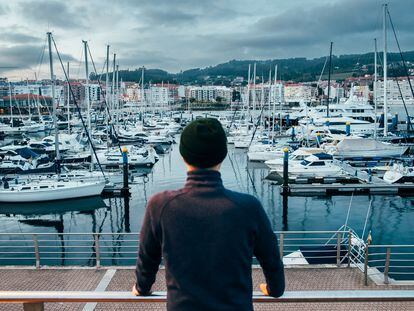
0, 230, 414, 311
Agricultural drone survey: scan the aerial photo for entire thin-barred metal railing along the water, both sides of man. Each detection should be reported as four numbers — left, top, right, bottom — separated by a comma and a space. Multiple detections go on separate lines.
0, 232, 414, 284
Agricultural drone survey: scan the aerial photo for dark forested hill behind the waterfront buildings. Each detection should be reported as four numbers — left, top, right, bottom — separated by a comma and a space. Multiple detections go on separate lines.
92, 51, 414, 85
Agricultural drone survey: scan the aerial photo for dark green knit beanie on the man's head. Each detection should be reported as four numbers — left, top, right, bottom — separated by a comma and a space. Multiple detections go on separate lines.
180, 118, 227, 168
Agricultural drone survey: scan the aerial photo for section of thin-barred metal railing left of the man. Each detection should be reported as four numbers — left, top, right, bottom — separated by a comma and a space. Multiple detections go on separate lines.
0, 233, 139, 268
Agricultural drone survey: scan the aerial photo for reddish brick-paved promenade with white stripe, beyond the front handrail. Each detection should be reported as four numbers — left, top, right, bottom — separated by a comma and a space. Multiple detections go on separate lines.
0, 268, 414, 311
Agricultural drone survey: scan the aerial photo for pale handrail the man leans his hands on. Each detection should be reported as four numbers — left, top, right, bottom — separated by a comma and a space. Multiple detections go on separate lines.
0, 290, 414, 304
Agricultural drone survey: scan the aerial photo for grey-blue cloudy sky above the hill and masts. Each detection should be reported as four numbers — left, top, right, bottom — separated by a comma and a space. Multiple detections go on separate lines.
0, 0, 414, 80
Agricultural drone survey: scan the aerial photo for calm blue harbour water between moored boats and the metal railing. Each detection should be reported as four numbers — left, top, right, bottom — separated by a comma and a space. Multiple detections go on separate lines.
0, 138, 414, 270
